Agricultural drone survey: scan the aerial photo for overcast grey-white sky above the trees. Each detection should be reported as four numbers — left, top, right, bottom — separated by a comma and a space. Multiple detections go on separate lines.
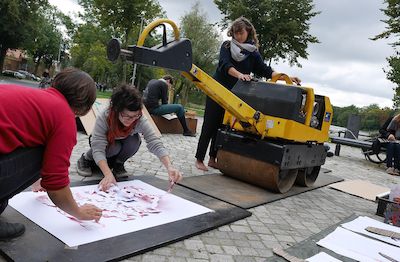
50, 0, 394, 107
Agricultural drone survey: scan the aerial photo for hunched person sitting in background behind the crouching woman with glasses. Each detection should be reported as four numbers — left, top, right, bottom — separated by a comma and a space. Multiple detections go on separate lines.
143, 75, 195, 136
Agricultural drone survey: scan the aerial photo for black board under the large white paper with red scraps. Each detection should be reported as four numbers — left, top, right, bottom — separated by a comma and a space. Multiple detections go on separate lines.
0, 176, 251, 262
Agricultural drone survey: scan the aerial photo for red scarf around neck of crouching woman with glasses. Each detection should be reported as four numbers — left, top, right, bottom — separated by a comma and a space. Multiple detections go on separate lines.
107, 110, 139, 144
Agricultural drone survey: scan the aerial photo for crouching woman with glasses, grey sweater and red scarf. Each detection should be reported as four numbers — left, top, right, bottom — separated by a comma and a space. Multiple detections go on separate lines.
77, 85, 182, 190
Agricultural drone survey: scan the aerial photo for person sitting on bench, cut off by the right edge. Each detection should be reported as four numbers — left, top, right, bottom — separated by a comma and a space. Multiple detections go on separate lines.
386, 114, 400, 176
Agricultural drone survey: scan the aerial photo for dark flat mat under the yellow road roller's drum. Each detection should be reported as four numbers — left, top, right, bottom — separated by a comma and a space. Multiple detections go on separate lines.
180, 173, 343, 209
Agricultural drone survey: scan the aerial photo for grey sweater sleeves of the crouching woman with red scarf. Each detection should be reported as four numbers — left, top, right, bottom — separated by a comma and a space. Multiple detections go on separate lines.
92, 109, 168, 164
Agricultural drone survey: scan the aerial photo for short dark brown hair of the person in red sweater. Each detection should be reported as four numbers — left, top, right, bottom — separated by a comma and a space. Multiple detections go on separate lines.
52, 67, 96, 116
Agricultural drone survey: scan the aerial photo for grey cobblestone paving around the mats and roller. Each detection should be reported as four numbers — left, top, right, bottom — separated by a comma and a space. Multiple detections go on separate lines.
65, 118, 400, 261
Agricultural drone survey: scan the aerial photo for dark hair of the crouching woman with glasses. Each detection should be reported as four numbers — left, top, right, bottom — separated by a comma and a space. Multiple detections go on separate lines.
110, 85, 143, 113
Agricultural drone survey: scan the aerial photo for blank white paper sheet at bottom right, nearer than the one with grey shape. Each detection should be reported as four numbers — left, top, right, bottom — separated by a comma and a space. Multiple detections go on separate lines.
317, 227, 400, 262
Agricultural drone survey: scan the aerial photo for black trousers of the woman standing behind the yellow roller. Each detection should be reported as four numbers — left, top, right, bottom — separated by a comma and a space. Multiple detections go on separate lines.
196, 97, 225, 161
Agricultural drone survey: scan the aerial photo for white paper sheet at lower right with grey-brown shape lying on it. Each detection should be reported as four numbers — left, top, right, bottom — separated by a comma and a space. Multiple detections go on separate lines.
342, 216, 400, 247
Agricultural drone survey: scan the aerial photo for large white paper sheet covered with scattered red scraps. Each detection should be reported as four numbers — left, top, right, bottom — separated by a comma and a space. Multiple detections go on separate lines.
9, 180, 213, 247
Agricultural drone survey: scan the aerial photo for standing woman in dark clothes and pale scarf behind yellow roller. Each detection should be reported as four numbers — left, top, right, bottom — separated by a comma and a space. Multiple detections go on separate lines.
195, 17, 300, 171
